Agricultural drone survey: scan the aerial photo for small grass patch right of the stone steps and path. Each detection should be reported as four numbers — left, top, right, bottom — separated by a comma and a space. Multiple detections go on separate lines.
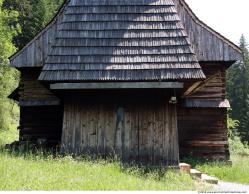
184, 155, 249, 185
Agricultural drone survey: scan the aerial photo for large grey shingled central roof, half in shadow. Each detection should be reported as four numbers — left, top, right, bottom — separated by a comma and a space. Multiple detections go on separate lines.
39, 0, 205, 81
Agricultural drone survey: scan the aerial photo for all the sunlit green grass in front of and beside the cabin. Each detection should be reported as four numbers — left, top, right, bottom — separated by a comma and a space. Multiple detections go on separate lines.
0, 128, 249, 191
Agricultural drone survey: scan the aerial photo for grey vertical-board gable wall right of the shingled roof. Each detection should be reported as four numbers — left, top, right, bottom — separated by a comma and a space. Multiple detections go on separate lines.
174, 0, 242, 61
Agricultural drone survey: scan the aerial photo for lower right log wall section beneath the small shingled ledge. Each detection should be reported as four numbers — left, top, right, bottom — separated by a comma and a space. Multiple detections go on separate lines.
178, 108, 229, 160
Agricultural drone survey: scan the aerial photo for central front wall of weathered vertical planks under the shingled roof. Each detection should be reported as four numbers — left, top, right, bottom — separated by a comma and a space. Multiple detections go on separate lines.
62, 91, 179, 166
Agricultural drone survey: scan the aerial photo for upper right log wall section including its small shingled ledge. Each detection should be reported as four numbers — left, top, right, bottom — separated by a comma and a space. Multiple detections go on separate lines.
182, 62, 230, 108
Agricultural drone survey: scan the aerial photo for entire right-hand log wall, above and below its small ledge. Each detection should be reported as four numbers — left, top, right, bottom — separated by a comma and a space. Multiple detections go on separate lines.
178, 62, 229, 160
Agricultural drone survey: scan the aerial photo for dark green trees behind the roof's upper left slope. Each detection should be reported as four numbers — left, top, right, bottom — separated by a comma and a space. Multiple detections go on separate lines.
4, 0, 63, 48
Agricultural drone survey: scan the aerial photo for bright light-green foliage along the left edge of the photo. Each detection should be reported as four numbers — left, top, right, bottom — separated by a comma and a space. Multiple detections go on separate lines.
0, 0, 20, 130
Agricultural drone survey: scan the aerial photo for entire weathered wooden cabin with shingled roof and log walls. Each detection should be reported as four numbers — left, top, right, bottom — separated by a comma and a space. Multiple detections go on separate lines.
11, 0, 241, 166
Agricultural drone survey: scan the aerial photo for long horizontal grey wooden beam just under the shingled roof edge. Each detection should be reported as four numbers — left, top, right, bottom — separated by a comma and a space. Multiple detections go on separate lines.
50, 82, 184, 90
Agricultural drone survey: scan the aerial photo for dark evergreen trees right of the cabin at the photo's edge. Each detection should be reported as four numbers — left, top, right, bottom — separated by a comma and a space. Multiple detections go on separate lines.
227, 35, 249, 142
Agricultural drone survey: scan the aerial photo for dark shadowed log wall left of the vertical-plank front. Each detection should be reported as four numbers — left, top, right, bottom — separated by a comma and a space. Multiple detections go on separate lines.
18, 69, 63, 144
